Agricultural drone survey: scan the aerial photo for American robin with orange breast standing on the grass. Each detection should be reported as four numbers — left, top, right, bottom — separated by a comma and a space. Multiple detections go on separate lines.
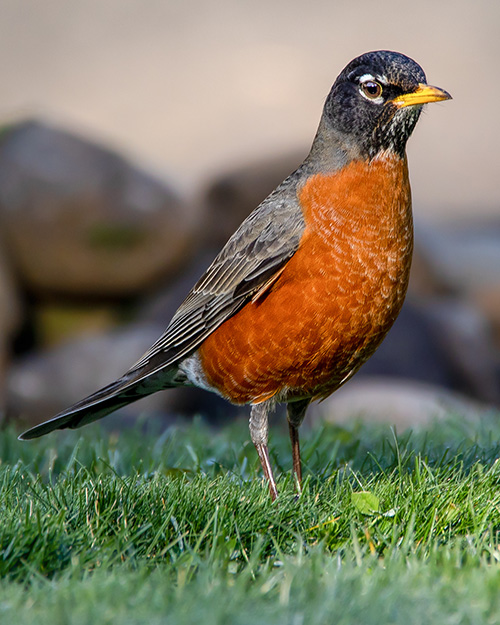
20, 51, 451, 499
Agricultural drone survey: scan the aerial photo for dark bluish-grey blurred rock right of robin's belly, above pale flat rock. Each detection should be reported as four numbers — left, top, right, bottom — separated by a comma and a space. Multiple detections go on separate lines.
357, 298, 500, 404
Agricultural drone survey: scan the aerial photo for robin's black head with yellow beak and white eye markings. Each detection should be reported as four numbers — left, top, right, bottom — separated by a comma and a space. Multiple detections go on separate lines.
324, 50, 451, 158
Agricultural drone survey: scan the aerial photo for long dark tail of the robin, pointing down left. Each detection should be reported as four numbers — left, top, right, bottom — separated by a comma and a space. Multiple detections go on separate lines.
19, 368, 175, 440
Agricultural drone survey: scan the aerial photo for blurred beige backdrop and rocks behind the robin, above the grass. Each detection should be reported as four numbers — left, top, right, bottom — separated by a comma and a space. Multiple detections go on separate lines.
0, 0, 500, 432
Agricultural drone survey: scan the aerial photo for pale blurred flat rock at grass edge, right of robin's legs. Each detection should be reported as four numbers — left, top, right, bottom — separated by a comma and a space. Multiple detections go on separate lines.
311, 378, 490, 429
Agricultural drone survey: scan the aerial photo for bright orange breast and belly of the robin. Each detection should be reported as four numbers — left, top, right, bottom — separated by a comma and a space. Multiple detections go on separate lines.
199, 157, 413, 403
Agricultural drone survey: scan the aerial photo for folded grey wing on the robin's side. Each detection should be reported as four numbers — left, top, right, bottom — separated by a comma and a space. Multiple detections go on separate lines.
130, 174, 305, 377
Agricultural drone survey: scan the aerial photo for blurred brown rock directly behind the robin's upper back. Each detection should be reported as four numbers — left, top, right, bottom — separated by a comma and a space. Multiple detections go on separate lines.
201, 153, 305, 250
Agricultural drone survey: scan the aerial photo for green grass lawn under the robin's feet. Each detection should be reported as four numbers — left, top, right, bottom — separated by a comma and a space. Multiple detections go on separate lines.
0, 414, 500, 625
